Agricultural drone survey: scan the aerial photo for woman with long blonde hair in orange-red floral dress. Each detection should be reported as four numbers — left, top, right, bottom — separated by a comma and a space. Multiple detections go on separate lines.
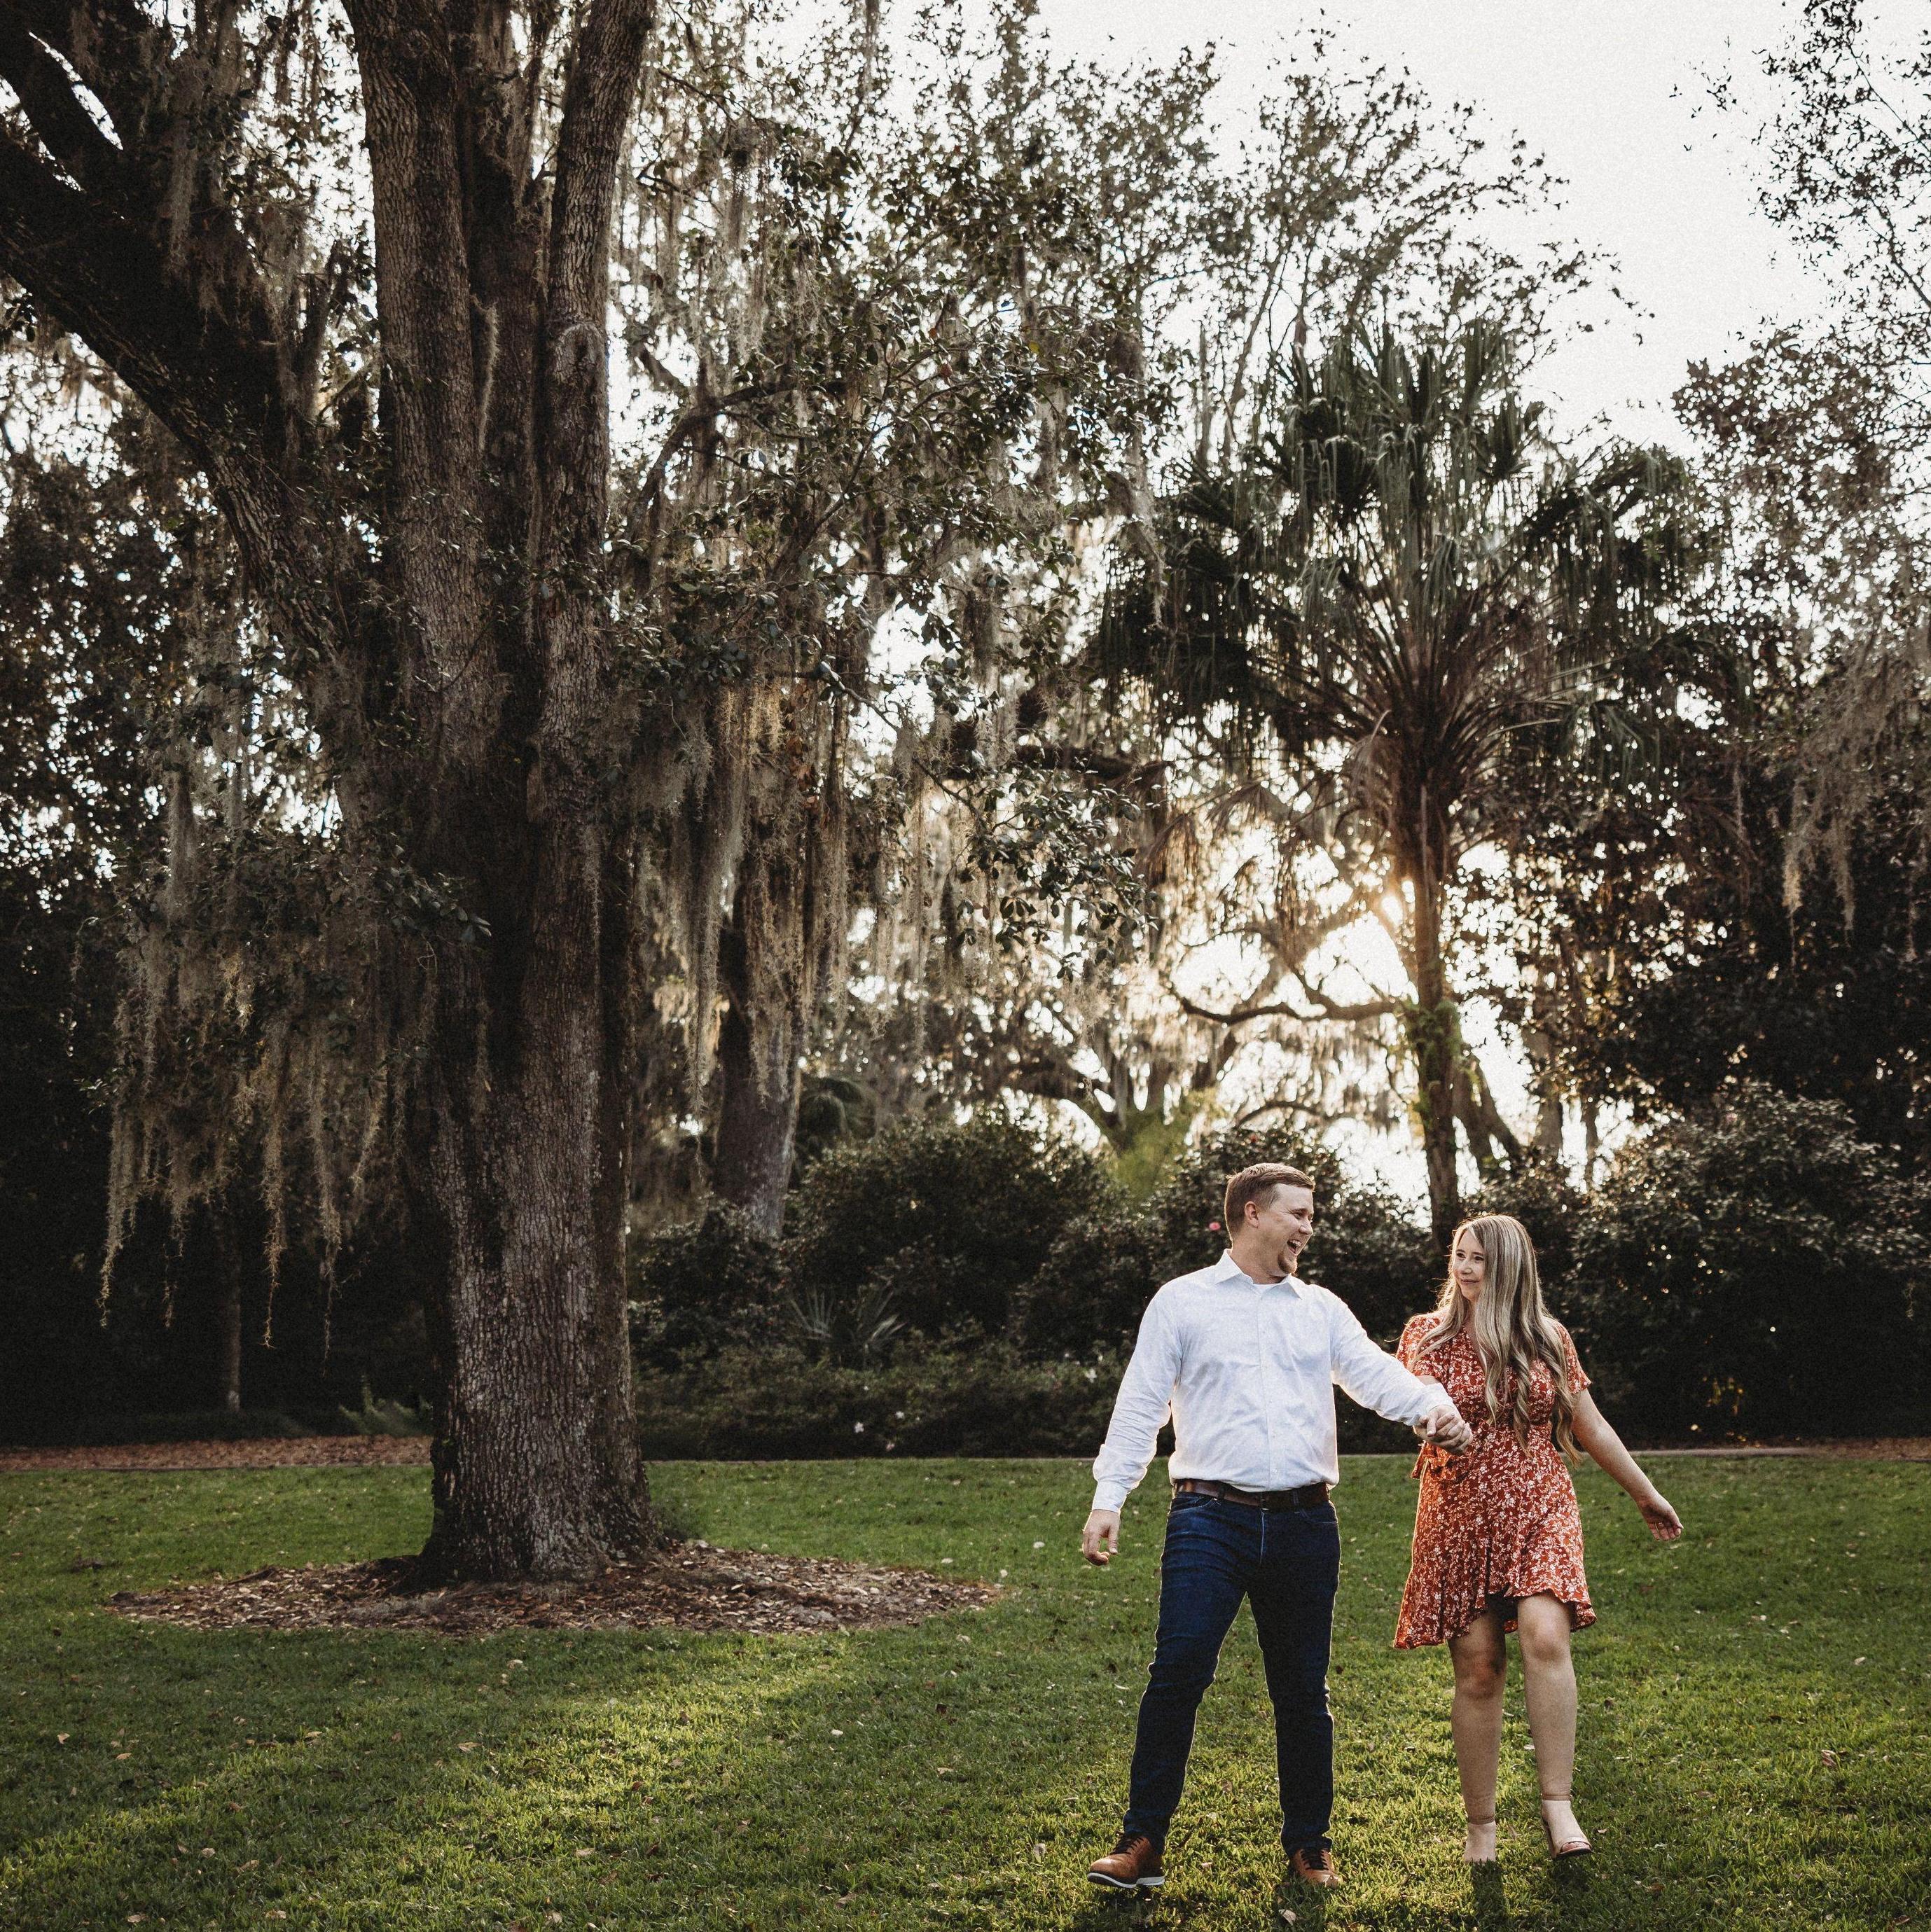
1396, 1214, 1684, 1864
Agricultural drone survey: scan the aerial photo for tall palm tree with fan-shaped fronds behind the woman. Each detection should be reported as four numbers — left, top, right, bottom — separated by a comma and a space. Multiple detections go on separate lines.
1096, 321, 1684, 1240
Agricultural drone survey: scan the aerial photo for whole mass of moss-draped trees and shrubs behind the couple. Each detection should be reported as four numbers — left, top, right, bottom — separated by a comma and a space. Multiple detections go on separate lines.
0, 0, 1931, 1491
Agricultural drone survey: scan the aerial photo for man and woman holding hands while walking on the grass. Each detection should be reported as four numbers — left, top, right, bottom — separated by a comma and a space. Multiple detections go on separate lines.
1081, 1163, 1682, 1891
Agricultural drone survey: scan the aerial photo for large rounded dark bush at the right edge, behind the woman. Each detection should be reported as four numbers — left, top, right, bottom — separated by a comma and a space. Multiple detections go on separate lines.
1564, 1086, 1931, 1436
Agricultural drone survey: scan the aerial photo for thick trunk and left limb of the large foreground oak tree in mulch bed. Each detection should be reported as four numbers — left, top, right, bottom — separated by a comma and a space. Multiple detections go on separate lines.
0, 0, 691, 1576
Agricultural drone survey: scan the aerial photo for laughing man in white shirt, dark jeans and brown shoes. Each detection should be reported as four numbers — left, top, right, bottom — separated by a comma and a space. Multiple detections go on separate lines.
1081, 1161, 1471, 1891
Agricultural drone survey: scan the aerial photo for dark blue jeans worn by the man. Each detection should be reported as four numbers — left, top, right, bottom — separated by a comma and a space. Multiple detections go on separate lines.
1125, 1492, 1341, 1853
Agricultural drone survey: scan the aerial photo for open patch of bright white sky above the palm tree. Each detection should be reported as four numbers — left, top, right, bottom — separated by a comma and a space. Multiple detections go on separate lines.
1040, 0, 1821, 438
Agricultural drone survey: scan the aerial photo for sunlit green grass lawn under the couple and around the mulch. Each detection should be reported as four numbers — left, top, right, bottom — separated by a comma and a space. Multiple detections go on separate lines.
0, 1459, 1931, 1932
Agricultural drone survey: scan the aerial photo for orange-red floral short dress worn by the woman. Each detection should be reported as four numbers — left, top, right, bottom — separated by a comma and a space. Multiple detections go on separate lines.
1396, 1314, 1597, 1650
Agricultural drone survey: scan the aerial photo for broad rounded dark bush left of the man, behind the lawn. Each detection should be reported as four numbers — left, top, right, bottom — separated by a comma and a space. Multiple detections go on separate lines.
784, 1113, 1112, 1337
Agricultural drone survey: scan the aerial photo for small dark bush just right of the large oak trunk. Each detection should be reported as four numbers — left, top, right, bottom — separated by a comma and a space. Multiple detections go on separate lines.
630, 1202, 783, 1372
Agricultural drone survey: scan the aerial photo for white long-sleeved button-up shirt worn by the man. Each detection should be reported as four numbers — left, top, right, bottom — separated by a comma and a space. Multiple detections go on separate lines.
1092, 1254, 1448, 1509
